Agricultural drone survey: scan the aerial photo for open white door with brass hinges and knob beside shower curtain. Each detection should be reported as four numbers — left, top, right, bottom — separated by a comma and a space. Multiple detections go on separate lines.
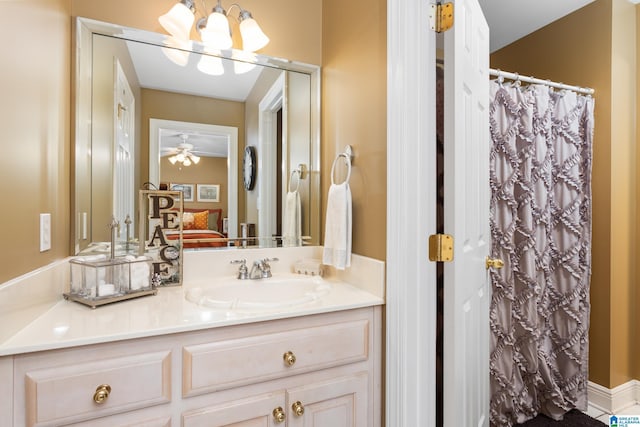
443, 0, 490, 426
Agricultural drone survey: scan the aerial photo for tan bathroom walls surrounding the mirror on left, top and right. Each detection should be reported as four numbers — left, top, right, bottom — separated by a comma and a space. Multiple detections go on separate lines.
0, 0, 386, 283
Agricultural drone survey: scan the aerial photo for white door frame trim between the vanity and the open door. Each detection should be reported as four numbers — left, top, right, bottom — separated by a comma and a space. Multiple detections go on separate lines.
385, 0, 436, 426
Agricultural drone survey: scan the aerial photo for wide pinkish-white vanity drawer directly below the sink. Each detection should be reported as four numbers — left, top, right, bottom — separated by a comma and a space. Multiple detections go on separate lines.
182, 319, 370, 396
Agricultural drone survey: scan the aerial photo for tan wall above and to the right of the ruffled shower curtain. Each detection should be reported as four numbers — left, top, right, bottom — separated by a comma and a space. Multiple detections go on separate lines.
491, 0, 637, 387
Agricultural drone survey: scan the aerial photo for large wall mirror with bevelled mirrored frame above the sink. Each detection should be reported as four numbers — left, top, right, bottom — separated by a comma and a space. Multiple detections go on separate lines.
74, 18, 320, 253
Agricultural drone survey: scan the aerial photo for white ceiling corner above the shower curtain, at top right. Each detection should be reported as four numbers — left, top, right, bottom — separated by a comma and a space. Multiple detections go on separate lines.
479, 0, 594, 52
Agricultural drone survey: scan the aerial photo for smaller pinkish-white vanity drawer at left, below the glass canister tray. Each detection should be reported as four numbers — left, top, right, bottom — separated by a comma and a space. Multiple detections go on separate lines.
25, 351, 171, 426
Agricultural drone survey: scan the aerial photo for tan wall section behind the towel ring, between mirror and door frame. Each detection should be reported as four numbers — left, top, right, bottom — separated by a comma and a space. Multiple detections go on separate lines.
321, 0, 393, 260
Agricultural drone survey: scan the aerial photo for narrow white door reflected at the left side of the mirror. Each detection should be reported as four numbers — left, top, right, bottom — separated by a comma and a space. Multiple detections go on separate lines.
113, 60, 136, 238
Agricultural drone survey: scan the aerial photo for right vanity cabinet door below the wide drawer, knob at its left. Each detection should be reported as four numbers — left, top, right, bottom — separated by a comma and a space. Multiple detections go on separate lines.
287, 372, 373, 427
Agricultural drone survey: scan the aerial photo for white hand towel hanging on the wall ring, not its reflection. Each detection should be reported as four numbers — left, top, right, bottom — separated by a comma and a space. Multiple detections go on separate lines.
322, 182, 351, 270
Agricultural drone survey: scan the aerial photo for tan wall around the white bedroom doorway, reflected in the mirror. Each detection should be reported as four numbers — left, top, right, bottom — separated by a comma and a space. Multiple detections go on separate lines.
140, 89, 245, 229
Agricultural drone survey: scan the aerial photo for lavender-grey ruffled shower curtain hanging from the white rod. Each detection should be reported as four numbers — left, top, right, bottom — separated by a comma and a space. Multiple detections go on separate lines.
489, 81, 594, 426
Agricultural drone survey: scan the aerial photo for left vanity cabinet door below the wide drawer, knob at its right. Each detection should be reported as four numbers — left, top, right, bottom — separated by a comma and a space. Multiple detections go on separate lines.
182, 392, 286, 427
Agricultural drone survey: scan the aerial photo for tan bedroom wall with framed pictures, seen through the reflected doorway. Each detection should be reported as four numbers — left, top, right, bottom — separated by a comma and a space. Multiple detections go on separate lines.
160, 157, 229, 218
